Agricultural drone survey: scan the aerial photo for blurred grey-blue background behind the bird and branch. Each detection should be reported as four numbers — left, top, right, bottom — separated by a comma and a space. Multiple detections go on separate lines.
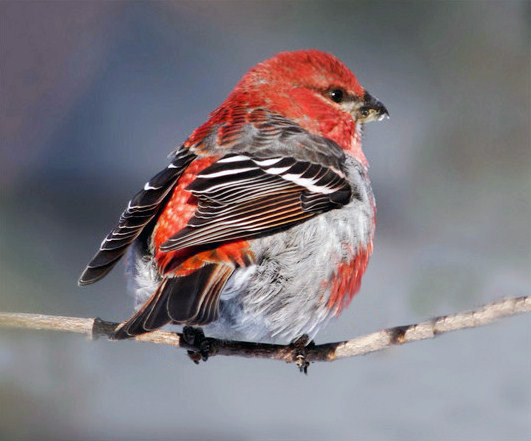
0, 1, 531, 441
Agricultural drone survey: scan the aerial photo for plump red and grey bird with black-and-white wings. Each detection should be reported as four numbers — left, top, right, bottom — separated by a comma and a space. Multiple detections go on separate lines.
79, 49, 389, 350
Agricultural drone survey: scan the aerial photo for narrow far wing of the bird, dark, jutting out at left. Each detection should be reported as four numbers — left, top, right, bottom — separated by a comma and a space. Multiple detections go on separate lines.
78, 148, 195, 285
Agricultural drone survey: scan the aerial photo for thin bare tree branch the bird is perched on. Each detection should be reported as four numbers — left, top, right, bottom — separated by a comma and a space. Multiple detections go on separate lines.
0, 296, 531, 362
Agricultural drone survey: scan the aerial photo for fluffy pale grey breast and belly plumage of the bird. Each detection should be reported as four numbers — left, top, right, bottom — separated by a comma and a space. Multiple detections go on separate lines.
207, 158, 374, 342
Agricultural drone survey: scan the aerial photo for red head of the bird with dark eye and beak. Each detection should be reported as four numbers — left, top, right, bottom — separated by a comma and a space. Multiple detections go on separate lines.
229, 49, 389, 163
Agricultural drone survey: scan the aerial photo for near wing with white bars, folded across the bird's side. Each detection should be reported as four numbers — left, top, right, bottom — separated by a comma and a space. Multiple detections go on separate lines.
161, 147, 352, 251
